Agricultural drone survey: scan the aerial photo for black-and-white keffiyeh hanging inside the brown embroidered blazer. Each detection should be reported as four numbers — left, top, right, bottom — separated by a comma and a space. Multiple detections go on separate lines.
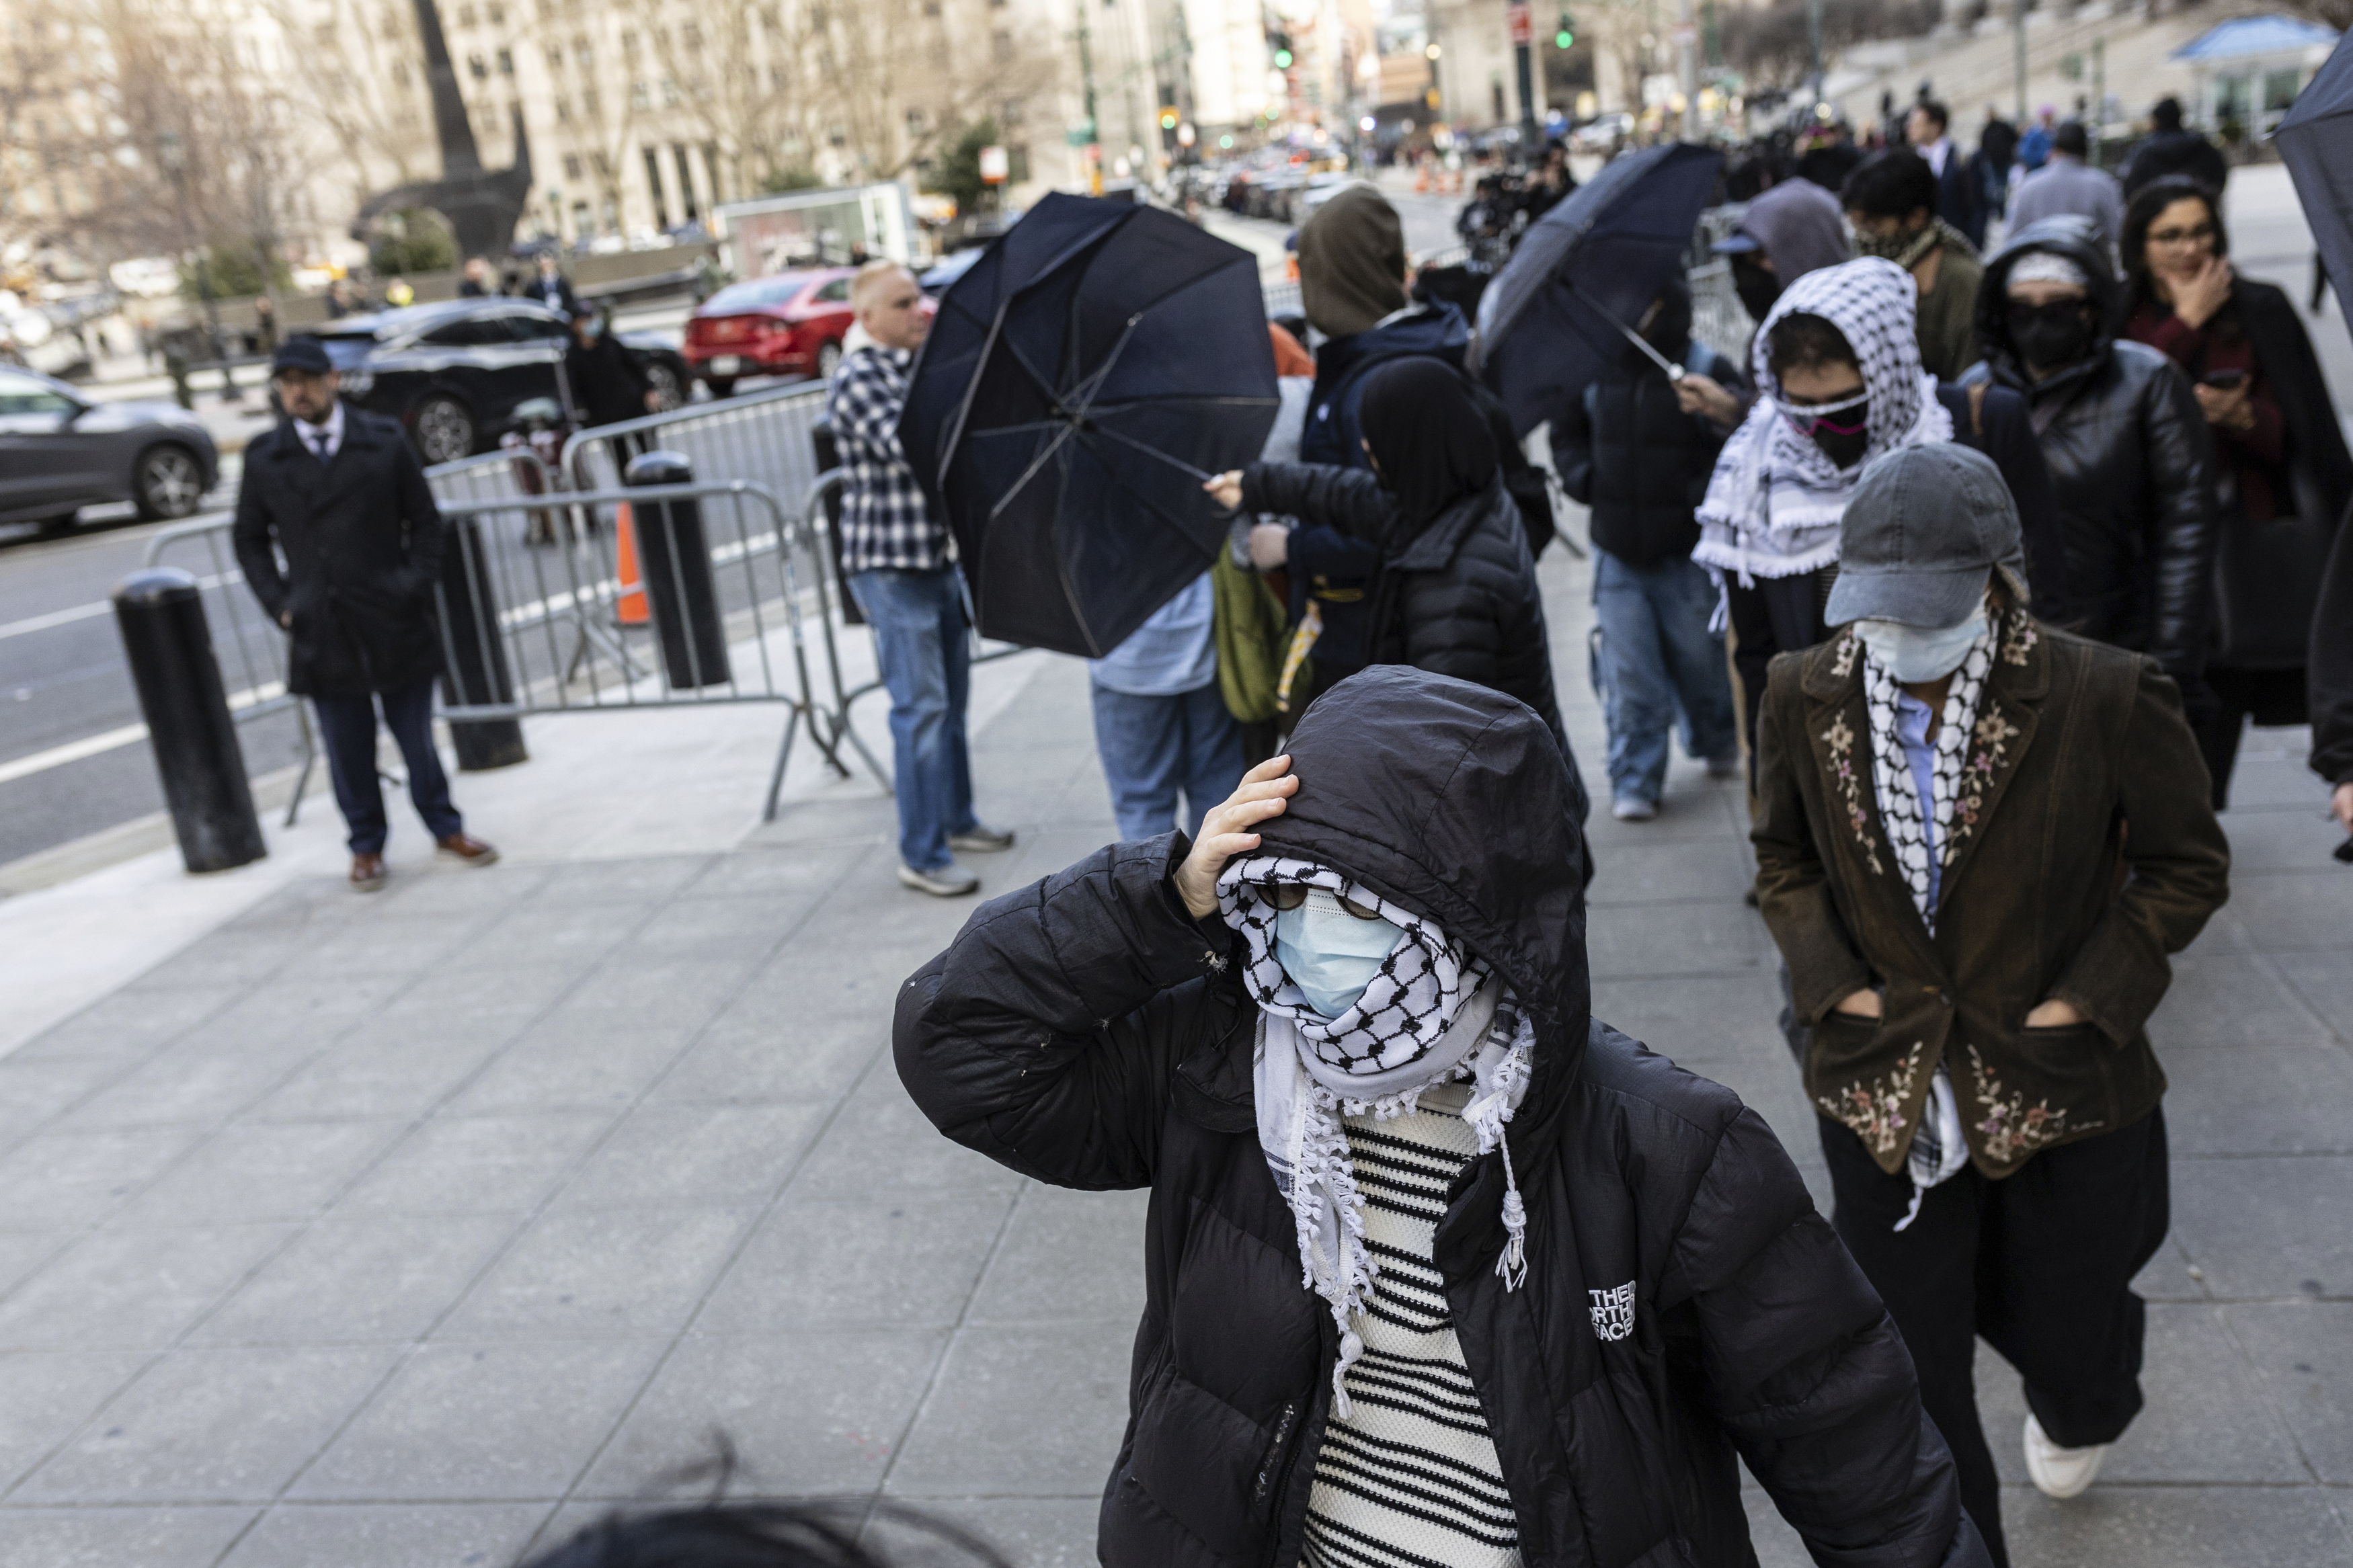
1849, 611, 2003, 1229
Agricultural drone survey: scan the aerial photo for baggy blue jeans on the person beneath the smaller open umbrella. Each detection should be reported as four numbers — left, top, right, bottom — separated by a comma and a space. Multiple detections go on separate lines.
1593, 550, 1739, 804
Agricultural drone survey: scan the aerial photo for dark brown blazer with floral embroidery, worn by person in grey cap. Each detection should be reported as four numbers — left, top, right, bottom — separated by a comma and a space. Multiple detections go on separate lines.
1751, 611, 2231, 1178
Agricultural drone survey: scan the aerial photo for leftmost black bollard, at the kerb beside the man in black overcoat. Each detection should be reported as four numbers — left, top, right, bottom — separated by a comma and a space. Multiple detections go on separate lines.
116, 567, 271, 872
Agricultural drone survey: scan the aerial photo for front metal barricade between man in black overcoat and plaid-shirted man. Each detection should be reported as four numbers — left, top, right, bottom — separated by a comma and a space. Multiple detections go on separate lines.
436, 480, 889, 821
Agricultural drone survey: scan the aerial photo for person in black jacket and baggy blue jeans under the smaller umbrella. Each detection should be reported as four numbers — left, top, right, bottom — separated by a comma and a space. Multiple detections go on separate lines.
1553, 275, 1749, 821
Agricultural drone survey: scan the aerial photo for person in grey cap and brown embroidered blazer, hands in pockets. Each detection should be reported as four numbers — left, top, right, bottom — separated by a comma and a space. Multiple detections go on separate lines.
1751, 444, 2231, 1563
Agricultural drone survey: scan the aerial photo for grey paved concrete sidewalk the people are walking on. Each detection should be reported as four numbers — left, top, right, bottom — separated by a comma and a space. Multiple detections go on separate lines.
0, 550, 2353, 1568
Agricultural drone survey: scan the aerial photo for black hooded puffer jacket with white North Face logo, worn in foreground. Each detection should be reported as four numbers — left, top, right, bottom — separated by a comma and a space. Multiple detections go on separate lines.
894, 667, 1989, 1568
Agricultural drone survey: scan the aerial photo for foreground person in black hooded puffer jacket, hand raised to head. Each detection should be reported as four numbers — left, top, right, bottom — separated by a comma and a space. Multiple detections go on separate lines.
894, 667, 1989, 1568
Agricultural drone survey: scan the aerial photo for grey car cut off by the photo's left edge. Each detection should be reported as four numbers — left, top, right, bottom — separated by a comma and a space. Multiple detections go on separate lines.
0, 364, 221, 531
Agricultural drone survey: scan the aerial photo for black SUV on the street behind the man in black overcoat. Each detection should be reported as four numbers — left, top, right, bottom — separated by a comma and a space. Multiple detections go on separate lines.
318, 296, 692, 466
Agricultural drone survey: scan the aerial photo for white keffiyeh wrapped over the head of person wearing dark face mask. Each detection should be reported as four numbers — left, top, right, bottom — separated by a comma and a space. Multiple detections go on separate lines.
1692, 256, 1953, 585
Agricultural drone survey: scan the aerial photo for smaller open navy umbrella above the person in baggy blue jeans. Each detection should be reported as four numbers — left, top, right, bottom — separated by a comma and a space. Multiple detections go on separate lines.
1471, 141, 1725, 435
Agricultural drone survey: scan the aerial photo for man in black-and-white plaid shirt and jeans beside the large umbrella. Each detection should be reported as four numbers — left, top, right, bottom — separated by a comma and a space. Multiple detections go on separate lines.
826, 261, 1014, 898
